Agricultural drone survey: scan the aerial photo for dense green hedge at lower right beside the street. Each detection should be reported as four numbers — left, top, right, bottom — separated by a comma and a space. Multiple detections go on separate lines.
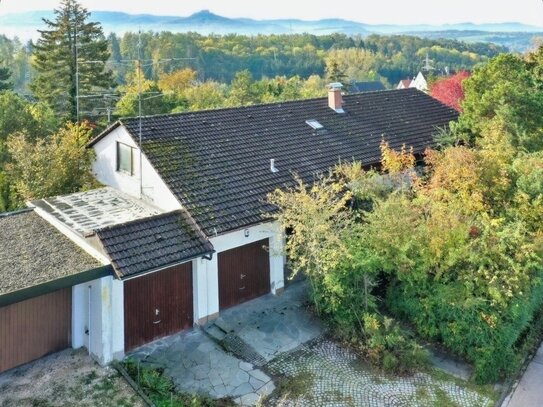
387, 272, 543, 383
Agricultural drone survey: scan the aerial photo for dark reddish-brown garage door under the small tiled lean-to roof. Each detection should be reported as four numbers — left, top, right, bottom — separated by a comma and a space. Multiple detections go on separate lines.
124, 262, 193, 351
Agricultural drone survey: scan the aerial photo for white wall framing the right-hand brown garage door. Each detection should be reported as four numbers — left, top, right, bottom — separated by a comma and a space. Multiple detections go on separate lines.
193, 222, 285, 324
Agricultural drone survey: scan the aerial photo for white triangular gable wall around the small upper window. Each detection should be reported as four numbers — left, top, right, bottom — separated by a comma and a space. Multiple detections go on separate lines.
92, 126, 181, 211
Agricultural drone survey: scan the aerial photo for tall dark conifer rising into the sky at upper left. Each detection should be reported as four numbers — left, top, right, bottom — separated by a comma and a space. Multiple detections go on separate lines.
30, 0, 113, 121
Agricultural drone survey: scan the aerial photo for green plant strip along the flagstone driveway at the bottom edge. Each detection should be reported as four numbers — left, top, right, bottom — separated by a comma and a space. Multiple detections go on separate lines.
122, 359, 236, 407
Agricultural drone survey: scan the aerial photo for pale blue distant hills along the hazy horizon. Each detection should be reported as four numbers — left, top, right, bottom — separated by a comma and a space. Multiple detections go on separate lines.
0, 10, 543, 50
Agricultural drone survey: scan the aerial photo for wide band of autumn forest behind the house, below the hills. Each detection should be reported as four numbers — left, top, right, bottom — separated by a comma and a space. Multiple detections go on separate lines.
0, 31, 506, 93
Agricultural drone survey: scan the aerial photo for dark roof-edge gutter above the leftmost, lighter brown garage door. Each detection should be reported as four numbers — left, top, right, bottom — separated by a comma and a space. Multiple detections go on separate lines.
0, 265, 113, 307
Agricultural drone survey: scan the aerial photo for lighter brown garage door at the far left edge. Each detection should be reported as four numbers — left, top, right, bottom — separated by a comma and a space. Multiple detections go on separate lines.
0, 287, 72, 372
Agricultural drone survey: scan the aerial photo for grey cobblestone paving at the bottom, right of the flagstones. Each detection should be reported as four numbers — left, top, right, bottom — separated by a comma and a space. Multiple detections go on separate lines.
266, 338, 492, 407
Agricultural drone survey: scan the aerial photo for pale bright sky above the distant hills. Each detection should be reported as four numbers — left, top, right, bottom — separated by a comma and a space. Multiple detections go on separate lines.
0, 0, 543, 26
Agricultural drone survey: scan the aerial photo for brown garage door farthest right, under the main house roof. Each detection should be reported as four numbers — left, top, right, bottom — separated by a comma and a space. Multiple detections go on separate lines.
218, 239, 270, 309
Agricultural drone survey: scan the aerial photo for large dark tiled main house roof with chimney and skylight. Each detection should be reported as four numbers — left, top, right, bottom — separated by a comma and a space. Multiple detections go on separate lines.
91, 89, 458, 236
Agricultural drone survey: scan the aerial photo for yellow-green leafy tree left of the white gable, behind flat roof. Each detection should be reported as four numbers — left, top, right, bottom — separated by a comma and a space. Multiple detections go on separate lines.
6, 123, 95, 200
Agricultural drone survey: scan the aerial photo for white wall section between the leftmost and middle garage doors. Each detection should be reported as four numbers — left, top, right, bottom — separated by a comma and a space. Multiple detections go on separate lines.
72, 276, 124, 365
